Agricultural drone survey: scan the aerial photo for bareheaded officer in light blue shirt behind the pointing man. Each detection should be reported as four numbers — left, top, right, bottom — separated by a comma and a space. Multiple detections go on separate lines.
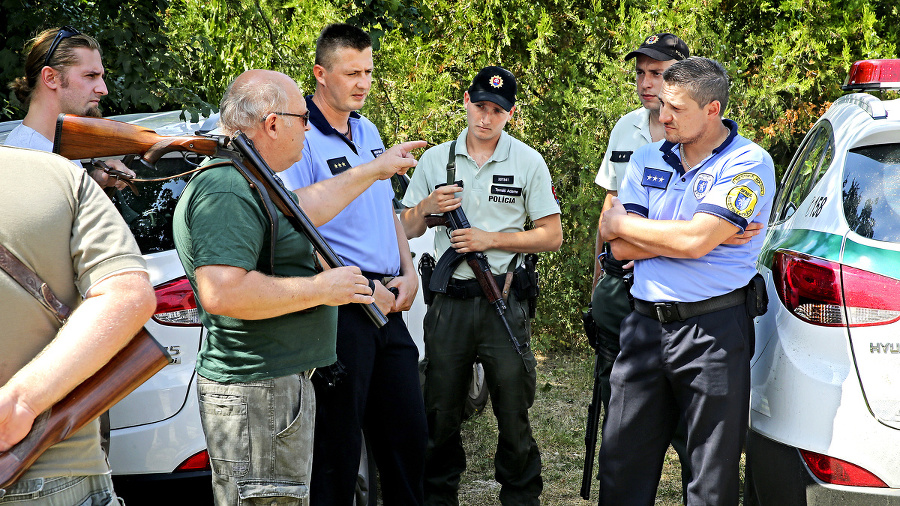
281, 24, 427, 506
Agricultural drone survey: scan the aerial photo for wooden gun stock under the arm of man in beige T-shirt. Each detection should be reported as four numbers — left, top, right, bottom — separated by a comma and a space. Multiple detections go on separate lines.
0, 329, 170, 497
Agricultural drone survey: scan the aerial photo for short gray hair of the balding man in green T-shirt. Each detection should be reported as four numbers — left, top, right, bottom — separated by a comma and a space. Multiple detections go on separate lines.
219, 79, 293, 136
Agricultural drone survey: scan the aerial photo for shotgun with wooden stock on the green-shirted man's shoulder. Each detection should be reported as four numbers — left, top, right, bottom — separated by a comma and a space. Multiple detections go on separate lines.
53, 114, 387, 327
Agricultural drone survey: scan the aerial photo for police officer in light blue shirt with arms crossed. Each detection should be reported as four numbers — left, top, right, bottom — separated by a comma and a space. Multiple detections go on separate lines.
599, 57, 775, 505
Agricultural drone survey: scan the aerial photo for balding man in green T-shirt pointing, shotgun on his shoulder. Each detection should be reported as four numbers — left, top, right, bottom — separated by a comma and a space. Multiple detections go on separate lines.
174, 70, 425, 506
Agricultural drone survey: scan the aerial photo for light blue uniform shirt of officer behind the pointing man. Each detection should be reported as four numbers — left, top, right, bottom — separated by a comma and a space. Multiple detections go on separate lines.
278, 96, 400, 276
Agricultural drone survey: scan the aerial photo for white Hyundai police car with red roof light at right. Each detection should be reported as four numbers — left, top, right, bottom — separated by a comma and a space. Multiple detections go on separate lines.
744, 60, 900, 505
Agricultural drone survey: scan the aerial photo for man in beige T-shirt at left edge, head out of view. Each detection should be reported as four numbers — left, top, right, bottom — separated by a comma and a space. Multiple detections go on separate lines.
0, 147, 156, 506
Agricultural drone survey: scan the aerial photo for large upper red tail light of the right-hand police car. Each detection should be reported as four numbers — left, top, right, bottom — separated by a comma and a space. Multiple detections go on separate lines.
772, 251, 900, 327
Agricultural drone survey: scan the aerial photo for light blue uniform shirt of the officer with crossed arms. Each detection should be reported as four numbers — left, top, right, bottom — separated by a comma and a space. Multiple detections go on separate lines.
619, 120, 775, 302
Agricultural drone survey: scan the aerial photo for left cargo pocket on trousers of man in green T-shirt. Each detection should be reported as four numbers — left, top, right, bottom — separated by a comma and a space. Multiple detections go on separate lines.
199, 393, 250, 477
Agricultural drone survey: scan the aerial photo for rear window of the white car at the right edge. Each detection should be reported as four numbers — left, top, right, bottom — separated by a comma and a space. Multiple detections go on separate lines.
842, 143, 900, 242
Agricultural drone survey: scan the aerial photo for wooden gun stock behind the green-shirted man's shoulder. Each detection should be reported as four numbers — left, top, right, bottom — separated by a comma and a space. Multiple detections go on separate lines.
53, 114, 224, 165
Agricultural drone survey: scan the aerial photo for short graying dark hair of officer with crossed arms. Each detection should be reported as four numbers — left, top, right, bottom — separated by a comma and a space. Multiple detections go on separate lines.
663, 56, 731, 116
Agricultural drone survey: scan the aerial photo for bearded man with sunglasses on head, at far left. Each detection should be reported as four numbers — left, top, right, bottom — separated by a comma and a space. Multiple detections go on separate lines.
6, 26, 134, 190
